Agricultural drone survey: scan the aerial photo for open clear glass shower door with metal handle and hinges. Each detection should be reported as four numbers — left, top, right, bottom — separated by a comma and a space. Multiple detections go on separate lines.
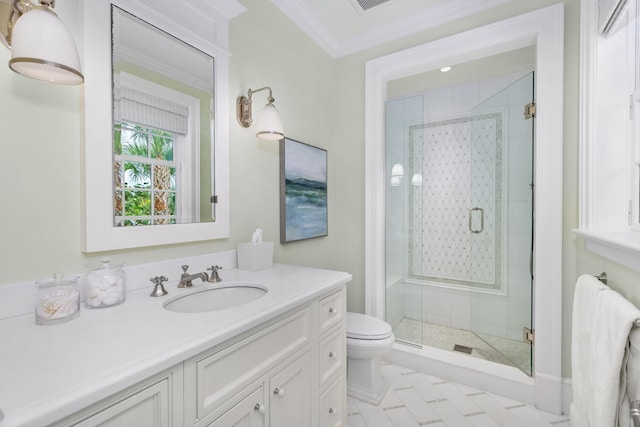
468, 72, 534, 375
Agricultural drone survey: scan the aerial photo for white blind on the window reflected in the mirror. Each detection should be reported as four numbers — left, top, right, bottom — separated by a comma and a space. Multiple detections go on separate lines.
113, 87, 189, 135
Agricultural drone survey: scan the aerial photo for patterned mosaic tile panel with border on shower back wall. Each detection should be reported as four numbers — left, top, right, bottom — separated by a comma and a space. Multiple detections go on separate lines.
408, 112, 503, 290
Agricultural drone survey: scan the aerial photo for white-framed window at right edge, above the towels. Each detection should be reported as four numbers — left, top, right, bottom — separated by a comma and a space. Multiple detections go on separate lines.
576, 0, 640, 271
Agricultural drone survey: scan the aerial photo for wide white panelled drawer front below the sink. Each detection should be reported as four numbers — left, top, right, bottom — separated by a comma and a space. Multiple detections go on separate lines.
189, 308, 310, 420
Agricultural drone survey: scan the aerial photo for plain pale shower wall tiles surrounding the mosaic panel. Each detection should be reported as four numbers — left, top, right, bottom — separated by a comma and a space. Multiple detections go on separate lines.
386, 73, 531, 340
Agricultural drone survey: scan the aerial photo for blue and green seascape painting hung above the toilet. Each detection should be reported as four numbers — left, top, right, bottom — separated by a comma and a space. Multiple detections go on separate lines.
280, 137, 329, 243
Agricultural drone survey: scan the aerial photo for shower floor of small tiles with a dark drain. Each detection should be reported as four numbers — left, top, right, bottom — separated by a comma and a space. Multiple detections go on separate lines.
393, 318, 531, 373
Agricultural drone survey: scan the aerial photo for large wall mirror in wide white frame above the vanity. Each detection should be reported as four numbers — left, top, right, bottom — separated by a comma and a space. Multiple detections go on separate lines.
82, 0, 229, 252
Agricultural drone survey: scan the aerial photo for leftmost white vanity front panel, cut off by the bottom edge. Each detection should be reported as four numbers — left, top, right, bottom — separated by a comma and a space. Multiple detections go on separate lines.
74, 379, 171, 427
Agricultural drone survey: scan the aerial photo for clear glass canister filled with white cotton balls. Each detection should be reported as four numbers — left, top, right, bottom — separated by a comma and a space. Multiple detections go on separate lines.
81, 258, 126, 308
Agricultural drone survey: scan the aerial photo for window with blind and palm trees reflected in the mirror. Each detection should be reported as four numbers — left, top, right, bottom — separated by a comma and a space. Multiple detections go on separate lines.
113, 72, 200, 227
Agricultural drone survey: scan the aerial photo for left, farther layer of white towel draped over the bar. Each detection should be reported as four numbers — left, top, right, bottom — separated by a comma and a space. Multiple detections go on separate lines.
570, 274, 607, 427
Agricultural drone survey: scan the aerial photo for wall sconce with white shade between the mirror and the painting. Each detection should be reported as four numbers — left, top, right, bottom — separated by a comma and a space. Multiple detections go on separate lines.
236, 86, 284, 141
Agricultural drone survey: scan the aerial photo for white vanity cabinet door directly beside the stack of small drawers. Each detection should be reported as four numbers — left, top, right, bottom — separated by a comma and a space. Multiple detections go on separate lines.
269, 353, 311, 427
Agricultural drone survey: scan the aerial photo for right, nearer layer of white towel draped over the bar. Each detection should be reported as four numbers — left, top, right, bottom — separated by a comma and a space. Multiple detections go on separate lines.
588, 289, 640, 427
